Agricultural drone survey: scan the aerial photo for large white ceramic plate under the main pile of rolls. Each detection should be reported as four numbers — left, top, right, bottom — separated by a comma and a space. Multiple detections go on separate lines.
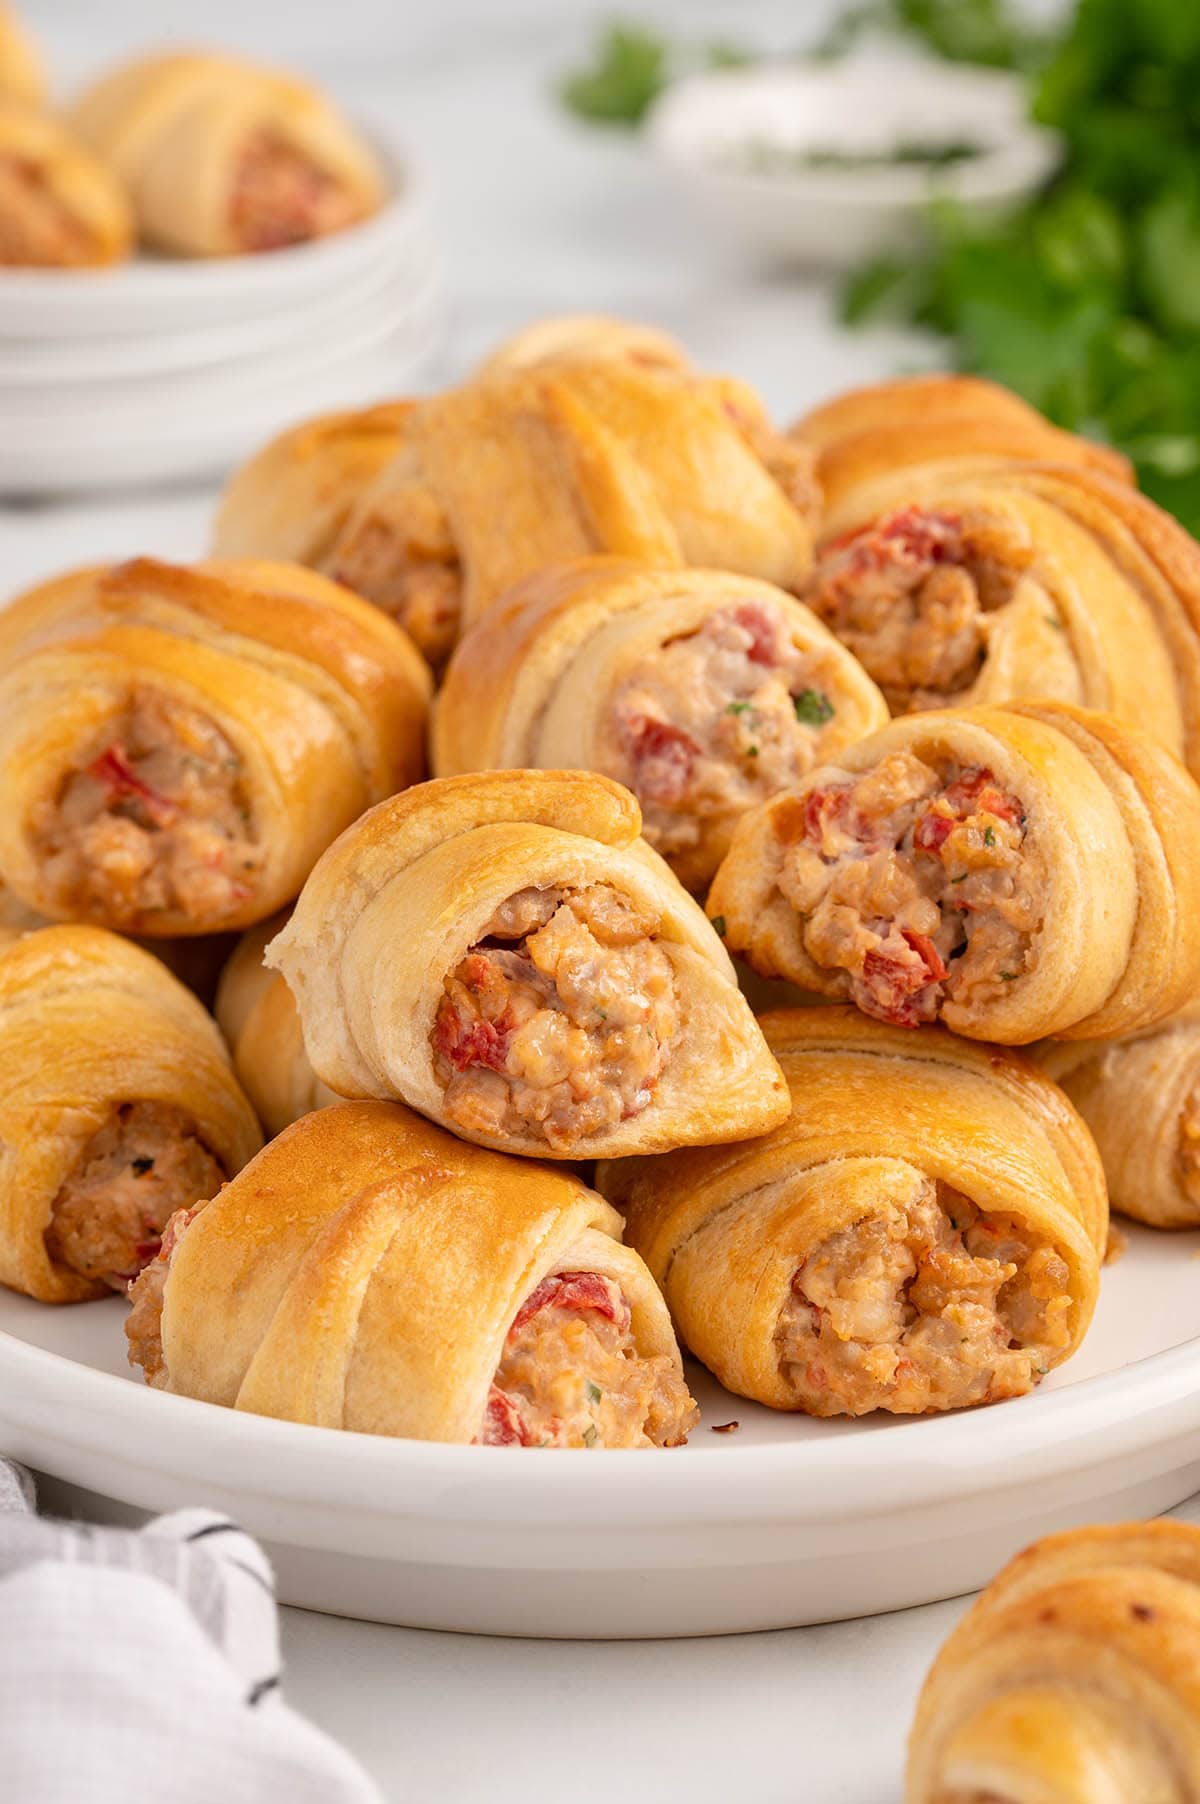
0, 1230, 1200, 1636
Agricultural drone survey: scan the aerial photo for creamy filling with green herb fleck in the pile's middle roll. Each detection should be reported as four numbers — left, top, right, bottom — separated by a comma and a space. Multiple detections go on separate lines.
606, 601, 835, 857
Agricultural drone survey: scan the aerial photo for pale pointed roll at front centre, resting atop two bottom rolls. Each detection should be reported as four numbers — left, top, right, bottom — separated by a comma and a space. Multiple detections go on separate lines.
267, 770, 787, 1158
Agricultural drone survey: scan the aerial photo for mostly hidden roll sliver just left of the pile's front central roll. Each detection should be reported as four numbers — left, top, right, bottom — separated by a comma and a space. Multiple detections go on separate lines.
215, 915, 339, 1135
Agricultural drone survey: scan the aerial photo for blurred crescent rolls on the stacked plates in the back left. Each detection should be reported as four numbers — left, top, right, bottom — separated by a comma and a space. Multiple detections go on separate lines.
0, 0, 384, 269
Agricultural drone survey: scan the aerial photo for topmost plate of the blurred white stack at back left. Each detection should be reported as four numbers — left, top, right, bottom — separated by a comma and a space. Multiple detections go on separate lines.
0, 128, 428, 339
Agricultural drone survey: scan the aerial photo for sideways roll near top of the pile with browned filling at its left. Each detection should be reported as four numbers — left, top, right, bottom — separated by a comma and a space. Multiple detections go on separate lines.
313, 355, 812, 664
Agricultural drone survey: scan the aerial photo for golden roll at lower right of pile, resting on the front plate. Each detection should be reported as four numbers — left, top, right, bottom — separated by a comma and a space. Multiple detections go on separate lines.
595, 1008, 1108, 1416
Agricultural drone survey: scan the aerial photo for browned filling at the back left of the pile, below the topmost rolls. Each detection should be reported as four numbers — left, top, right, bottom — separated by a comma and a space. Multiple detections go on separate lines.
328, 471, 462, 666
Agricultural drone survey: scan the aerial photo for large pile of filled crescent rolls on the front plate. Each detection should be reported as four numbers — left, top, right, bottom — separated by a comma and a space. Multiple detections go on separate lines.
0, 303, 1200, 1472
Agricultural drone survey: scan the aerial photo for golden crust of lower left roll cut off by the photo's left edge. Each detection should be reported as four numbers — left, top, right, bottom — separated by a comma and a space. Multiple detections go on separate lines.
0, 927, 262, 1302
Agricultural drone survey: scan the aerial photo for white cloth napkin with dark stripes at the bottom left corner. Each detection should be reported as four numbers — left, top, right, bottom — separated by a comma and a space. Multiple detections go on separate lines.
0, 1459, 381, 1804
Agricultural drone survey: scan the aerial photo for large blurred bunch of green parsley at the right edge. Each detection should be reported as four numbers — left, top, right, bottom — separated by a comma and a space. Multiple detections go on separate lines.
843, 0, 1200, 534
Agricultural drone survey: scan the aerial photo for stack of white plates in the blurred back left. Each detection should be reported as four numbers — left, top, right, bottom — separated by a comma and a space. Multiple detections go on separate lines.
0, 132, 442, 496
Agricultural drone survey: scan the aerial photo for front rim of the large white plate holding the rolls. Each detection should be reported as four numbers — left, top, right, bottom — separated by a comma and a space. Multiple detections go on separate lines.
0, 1306, 1200, 1530
